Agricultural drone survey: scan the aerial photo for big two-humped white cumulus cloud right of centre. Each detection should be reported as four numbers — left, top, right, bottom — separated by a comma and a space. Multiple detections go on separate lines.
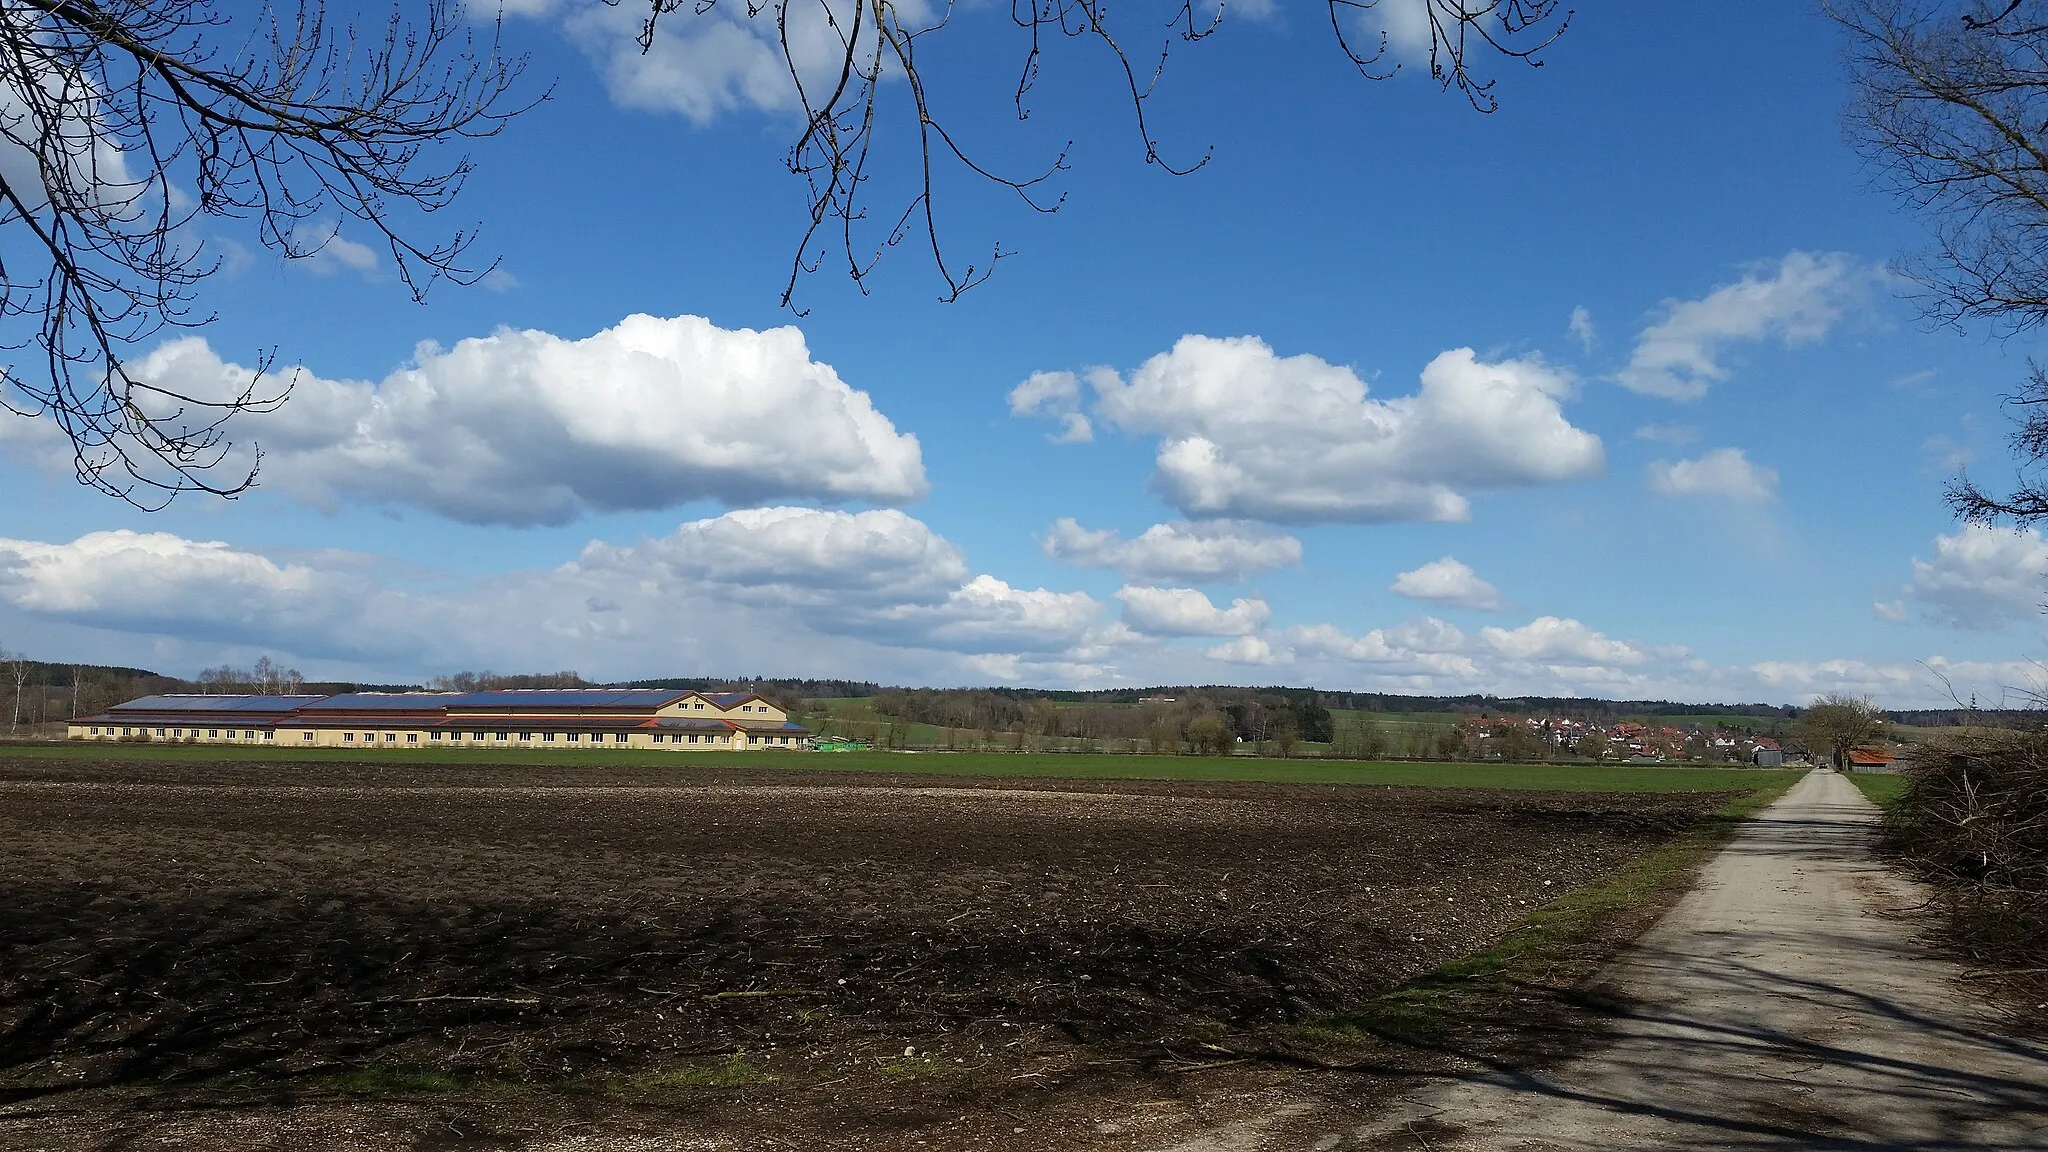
1019, 336, 1604, 523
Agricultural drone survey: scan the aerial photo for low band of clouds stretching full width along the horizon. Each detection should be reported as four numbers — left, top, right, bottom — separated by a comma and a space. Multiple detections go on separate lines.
0, 522, 2040, 707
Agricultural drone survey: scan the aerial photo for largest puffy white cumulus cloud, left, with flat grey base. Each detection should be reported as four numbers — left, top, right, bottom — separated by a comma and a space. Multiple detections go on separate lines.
116, 316, 928, 525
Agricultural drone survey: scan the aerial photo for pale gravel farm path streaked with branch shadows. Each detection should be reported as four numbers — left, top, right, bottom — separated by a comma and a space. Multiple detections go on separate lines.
1180, 771, 2048, 1152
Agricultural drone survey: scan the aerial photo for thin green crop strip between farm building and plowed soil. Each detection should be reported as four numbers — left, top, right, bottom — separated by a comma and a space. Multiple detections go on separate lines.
0, 744, 1798, 791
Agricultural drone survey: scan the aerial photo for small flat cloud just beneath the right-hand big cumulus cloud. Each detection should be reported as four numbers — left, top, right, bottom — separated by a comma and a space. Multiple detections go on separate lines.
1044, 517, 1300, 582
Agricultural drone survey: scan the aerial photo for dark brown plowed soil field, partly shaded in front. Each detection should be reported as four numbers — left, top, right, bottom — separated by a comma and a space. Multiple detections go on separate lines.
0, 760, 1718, 1146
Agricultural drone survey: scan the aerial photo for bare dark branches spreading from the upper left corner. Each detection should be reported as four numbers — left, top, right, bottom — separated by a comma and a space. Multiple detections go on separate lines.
0, 0, 520, 506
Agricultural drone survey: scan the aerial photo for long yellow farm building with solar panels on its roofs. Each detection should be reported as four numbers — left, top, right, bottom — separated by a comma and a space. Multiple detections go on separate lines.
70, 689, 809, 752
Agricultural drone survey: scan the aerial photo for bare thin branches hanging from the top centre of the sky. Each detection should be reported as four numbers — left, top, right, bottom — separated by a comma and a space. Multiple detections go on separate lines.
630, 0, 1573, 316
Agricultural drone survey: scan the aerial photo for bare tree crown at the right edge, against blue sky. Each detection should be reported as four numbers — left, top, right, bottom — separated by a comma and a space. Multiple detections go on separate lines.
1829, 0, 2048, 525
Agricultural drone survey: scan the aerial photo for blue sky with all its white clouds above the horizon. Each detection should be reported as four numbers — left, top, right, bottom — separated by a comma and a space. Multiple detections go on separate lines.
0, 0, 2048, 705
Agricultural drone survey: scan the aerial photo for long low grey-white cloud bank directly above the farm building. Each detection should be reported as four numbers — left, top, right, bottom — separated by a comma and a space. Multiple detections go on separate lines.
0, 508, 1105, 676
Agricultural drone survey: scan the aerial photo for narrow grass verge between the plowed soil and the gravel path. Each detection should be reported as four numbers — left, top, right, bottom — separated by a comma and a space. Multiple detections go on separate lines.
1300, 781, 1792, 1060
